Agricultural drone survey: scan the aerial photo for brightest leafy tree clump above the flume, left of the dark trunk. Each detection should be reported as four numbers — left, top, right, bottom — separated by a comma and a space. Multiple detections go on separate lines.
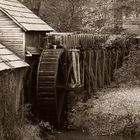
83, 0, 113, 32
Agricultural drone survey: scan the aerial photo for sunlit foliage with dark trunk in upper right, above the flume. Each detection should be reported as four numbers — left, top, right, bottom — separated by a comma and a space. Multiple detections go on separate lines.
83, 0, 140, 32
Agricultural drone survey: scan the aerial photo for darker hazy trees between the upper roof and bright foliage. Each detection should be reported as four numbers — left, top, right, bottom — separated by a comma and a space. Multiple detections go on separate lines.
20, 0, 88, 32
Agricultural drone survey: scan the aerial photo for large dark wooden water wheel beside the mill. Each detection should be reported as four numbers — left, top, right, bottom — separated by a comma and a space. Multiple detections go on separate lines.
37, 49, 66, 127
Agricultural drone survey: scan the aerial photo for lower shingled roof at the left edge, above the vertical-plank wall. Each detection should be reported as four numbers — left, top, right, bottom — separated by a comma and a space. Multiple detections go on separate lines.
0, 44, 29, 71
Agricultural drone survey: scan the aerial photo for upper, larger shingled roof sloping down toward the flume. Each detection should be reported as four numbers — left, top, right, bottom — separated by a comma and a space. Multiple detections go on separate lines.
0, 0, 53, 31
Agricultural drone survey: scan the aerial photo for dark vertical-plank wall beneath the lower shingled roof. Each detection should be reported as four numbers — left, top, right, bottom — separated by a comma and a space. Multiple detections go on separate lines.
0, 68, 24, 137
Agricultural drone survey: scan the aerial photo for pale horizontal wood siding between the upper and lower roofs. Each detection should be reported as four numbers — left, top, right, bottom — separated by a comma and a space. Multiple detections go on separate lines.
0, 11, 25, 58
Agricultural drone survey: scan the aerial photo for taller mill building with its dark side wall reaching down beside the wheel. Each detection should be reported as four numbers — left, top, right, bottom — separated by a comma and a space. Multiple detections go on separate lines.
0, 0, 53, 112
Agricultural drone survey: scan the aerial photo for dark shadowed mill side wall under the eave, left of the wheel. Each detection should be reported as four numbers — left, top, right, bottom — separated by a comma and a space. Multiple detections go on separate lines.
25, 31, 45, 114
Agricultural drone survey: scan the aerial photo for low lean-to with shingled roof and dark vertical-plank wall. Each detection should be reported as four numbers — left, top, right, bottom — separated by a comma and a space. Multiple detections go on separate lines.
0, 43, 29, 132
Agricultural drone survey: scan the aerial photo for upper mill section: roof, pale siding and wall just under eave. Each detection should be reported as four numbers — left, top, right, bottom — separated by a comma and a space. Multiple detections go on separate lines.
0, 0, 53, 59
